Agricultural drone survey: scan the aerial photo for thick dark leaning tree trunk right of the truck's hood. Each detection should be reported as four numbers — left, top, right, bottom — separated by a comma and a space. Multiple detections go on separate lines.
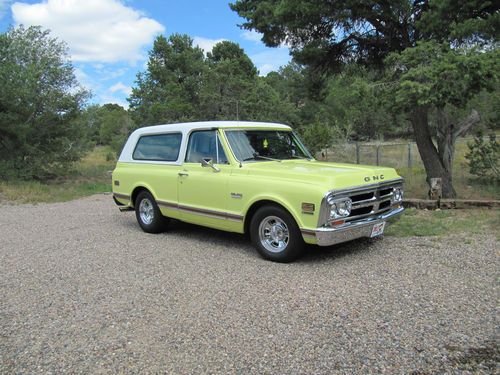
410, 106, 457, 198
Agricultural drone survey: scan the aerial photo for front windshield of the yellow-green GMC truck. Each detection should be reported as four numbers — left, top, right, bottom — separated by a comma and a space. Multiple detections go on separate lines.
226, 130, 312, 161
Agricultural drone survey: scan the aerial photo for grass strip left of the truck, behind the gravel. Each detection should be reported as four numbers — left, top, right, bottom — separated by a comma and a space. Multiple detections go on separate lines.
0, 147, 116, 203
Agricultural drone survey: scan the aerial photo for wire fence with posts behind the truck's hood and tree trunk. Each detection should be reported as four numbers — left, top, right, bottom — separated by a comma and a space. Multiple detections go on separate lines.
318, 137, 500, 199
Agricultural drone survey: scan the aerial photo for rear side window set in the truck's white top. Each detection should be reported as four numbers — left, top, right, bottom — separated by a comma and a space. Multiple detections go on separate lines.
132, 133, 182, 161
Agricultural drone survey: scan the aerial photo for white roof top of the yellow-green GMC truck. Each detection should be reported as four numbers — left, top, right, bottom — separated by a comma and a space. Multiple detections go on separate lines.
134, 121, 291, 135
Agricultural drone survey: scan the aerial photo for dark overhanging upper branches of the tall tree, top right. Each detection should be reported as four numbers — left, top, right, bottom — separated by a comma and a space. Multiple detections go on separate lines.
230, 0, 500, 71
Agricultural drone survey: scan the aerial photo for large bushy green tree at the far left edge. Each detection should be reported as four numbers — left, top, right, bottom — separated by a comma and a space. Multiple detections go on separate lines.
0, 26, 89, 179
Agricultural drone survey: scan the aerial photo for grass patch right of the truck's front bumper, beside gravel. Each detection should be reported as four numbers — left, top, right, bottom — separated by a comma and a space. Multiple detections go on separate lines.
385, 208, 500, 237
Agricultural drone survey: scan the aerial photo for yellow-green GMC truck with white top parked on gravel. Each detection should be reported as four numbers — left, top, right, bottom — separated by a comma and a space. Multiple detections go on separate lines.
112, 121, 403, 262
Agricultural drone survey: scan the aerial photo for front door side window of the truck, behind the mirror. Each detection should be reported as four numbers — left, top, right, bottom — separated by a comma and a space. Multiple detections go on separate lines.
186, 130, 227, 164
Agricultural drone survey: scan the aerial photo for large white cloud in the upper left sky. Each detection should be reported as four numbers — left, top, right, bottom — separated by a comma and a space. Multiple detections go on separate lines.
11, 0, 165, 63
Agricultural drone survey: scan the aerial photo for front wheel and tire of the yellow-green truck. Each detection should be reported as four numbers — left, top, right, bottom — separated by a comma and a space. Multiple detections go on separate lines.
250, 206, 304, 263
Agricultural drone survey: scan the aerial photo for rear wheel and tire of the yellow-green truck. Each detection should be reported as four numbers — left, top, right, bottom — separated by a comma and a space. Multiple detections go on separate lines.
135, 191, 169, 233
